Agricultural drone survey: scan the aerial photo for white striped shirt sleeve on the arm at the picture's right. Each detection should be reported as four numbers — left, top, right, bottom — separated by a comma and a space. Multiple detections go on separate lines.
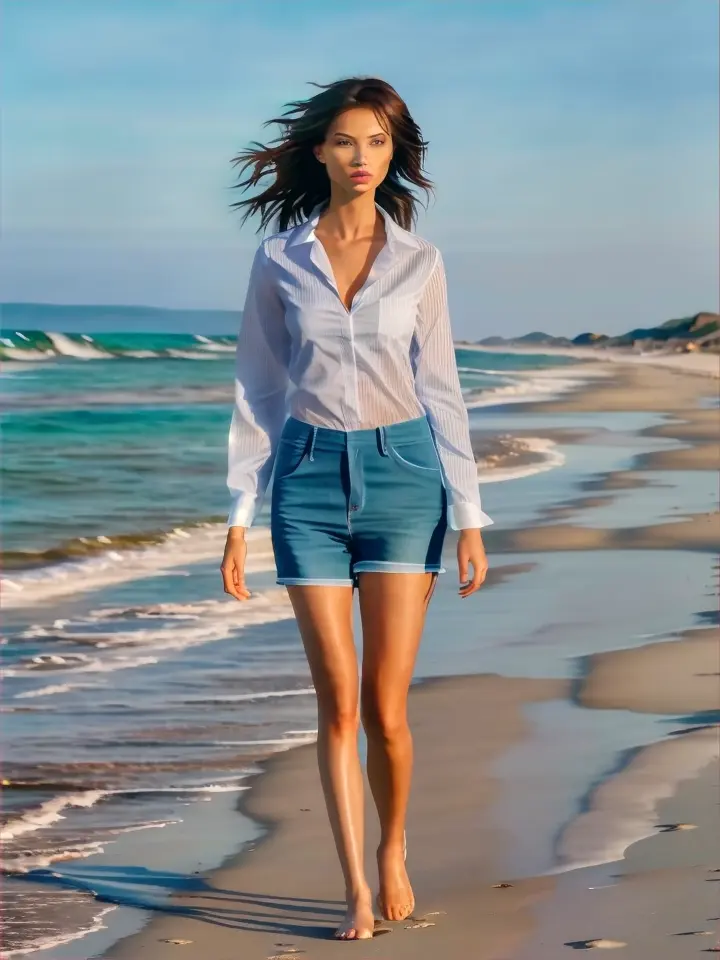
413, 251, 493, 530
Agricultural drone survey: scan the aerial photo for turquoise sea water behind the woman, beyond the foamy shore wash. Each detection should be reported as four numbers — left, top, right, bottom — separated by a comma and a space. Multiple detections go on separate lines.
2, 331, 573, 571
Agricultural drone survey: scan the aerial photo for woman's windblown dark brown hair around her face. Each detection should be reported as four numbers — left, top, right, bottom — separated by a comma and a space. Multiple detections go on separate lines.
231, 77, 432, 231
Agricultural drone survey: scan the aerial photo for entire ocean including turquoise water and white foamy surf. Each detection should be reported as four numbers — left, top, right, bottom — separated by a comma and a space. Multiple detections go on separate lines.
0, 318, 652, 960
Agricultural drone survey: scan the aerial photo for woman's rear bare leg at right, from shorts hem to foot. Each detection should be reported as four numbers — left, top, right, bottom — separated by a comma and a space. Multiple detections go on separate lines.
359, 572, 437, 920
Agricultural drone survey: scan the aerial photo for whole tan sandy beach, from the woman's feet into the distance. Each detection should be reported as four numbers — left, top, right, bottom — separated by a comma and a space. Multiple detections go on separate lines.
98, 357, 720, 960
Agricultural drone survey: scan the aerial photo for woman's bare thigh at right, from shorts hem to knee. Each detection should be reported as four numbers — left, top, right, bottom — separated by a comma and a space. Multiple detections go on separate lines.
358, 572, 438, 706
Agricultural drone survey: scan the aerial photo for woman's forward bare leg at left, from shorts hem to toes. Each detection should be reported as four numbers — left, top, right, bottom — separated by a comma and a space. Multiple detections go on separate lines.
287, 585, 375, 940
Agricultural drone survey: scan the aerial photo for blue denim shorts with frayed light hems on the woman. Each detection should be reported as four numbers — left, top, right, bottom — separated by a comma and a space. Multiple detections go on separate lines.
270, 417, 447, 586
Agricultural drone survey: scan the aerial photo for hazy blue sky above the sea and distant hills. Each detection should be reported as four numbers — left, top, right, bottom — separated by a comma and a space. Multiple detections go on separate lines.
0, 0, 718, 339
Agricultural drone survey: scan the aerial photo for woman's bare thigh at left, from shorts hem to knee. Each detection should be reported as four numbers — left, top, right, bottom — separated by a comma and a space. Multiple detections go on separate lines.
286, 585, 358, 712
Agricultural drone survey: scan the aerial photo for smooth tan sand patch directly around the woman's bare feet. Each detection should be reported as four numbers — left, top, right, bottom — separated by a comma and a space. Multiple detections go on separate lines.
101, 676, 567, 960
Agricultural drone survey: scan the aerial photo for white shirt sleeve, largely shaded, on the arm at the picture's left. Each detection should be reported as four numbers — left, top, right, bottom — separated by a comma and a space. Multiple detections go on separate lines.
227, 244, 290, 527
